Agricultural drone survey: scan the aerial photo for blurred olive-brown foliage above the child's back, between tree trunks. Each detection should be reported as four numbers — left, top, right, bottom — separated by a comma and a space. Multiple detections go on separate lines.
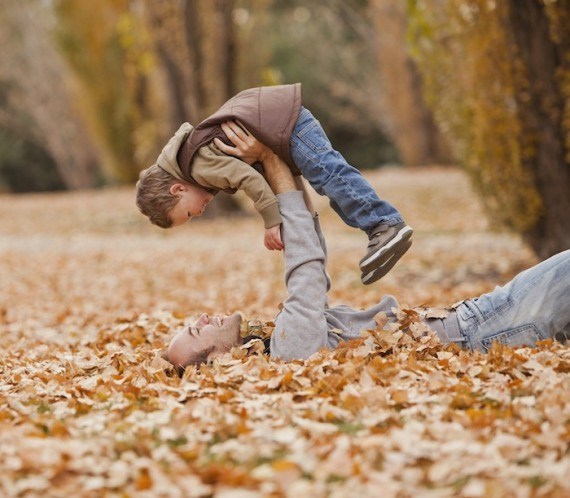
261, 0, 398, 168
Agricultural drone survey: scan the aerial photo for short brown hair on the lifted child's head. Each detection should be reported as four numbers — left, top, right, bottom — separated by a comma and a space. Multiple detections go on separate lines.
136, 164, 181, 228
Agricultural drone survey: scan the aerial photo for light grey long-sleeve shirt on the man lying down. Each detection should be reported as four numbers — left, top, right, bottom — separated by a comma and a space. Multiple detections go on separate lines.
270, 192, 398, 360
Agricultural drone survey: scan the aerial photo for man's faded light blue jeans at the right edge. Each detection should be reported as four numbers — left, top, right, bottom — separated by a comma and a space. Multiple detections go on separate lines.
448, 250, 570, 352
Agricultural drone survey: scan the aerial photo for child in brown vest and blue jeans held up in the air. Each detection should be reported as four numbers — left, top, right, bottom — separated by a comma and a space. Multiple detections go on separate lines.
136, 83, 413, 284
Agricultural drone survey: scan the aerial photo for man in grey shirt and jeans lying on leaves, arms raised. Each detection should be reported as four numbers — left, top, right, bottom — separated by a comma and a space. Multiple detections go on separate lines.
166, 123, 570, 372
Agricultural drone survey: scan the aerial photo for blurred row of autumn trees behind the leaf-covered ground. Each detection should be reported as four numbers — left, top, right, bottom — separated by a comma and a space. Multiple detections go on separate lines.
0, 0, 570, 257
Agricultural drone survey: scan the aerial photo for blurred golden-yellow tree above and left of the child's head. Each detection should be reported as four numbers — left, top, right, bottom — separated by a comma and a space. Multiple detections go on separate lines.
54, 0, 164, 182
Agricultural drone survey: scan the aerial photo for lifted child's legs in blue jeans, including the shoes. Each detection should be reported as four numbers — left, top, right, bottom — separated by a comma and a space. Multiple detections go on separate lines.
291, 107, 413, 284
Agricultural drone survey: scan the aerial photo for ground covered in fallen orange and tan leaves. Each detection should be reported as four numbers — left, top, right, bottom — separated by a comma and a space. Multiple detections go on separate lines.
0, 168, 570, 498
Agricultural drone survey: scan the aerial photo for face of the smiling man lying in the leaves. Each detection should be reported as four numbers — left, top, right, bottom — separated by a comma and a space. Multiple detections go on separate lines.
167, 313, 242, 367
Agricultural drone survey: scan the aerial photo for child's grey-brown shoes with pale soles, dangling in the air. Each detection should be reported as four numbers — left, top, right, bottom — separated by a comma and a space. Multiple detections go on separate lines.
360, 222, 414, 284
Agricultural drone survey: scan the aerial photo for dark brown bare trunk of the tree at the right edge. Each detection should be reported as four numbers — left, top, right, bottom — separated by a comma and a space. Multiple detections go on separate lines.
508, 0, 570, 258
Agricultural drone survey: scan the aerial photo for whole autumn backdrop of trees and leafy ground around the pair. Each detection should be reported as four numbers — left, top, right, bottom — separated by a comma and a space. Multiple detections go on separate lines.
0, 0, 570, 498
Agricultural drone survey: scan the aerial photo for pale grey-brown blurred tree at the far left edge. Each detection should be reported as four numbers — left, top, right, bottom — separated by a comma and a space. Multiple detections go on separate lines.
0, 0, 99, 190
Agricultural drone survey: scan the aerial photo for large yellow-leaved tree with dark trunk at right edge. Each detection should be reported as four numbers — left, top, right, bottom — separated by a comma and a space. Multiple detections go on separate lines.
410, 0, 570, 258
